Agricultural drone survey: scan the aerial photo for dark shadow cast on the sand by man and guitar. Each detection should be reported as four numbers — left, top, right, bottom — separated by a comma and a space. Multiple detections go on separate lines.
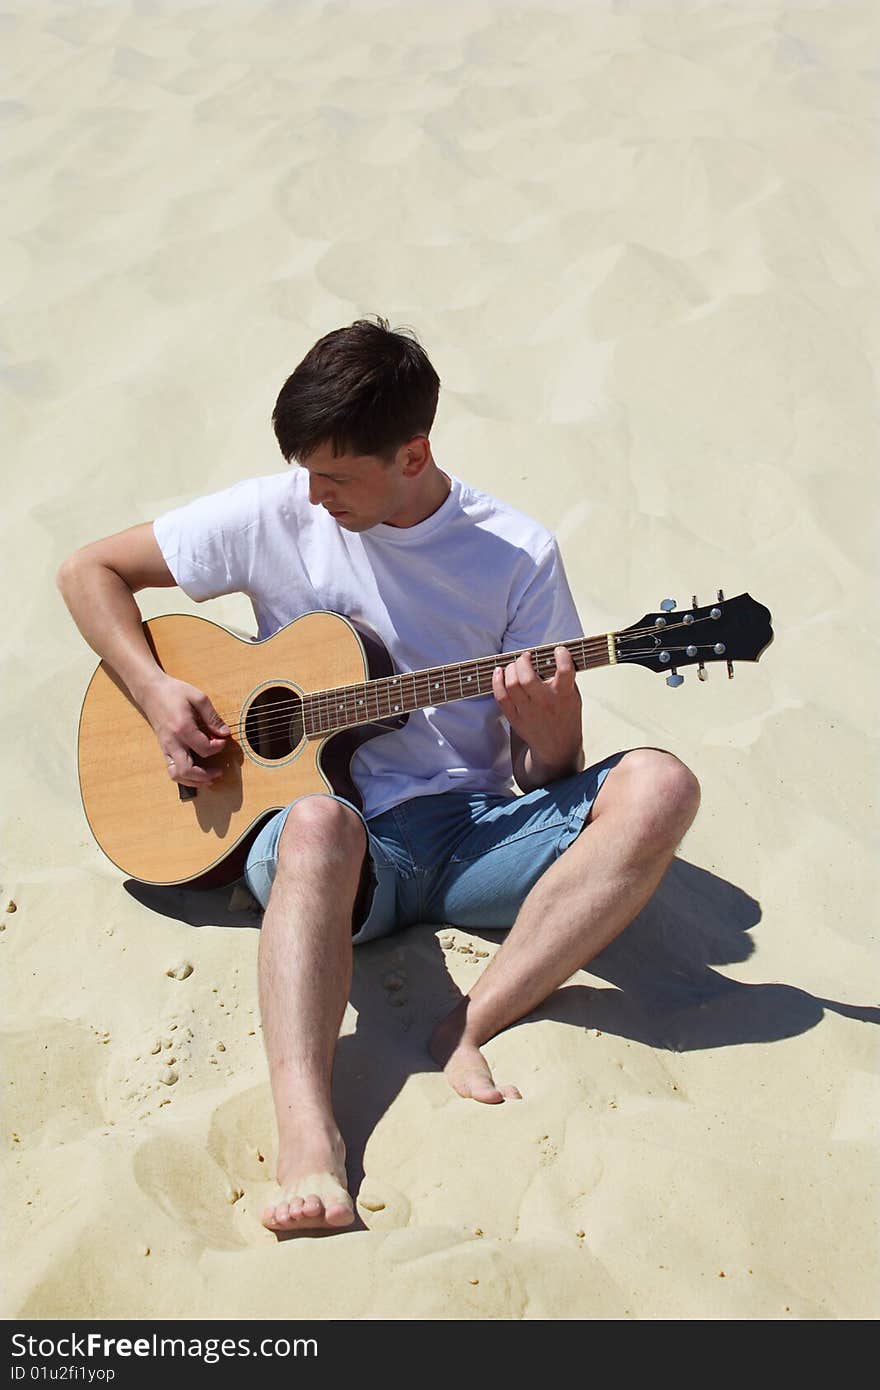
125, 859, 880, 1206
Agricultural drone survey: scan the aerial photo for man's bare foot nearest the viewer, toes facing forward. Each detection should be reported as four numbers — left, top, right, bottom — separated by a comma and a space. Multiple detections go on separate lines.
263, 1133, 355, 1232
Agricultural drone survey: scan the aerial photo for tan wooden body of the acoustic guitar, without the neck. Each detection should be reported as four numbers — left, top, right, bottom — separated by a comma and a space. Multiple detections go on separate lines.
78, 613, 407, 887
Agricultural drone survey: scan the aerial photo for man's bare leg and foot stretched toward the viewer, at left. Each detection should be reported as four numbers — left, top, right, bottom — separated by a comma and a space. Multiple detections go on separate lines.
259, 796, 366, 1230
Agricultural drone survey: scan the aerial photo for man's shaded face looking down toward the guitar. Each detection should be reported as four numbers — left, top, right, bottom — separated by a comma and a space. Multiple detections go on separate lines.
302, 443, 413, 531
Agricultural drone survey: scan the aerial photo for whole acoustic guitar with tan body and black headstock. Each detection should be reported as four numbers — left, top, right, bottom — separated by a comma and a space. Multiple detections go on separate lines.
78, 591, 773, 887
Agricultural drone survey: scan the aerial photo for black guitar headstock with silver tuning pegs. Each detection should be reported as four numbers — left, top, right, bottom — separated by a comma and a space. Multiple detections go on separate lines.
614, 589, 773, 685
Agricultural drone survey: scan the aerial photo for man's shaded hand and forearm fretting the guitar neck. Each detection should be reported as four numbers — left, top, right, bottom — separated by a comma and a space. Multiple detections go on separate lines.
492, 646, 585, 791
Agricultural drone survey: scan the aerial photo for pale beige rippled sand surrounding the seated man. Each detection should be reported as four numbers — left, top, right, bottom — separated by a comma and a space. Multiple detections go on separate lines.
0, 0, 880, 1319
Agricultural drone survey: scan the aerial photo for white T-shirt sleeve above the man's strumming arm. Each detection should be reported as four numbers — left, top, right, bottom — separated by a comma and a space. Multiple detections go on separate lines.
153, 480, 257, 603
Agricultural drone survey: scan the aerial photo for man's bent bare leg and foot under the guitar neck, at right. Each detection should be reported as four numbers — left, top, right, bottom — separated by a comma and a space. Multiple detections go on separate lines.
430, 748, 699, 1105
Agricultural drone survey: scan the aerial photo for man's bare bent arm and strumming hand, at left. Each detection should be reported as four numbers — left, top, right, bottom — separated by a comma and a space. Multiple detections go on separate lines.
56, 521, 229, 787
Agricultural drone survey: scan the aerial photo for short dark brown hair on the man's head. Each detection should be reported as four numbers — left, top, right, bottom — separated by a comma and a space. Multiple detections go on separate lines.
272, 316, 439, 463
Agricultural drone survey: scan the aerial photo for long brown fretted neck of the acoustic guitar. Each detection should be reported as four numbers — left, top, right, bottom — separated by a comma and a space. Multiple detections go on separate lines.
303, 632, 617, 735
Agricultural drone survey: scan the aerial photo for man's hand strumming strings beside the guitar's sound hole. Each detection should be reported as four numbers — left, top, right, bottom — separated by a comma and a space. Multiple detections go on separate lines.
140, 671, 231, 787
